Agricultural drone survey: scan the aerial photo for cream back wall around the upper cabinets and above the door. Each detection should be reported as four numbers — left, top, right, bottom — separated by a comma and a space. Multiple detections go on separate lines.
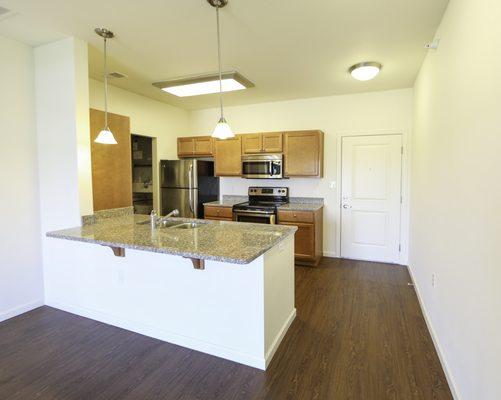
190, 89, 412, 262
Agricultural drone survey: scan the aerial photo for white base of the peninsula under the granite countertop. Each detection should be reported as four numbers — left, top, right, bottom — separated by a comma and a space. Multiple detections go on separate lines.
45, 235, 296, 370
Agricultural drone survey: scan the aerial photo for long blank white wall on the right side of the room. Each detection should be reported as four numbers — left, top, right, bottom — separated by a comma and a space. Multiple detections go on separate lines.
410, 0, 501, 400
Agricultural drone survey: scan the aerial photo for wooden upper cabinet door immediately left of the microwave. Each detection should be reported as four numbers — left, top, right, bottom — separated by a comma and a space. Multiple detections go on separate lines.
214, 135, 242, 176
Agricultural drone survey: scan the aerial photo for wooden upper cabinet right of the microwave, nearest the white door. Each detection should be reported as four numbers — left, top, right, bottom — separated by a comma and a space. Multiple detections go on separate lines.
284, 131, 324, 178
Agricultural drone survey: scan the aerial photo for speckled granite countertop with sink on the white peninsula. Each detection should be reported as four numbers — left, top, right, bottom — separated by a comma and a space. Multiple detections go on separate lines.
47, 214, 297, 264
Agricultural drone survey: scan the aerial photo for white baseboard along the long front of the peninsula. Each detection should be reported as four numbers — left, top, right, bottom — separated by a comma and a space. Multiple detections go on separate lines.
46, 300, 272, 370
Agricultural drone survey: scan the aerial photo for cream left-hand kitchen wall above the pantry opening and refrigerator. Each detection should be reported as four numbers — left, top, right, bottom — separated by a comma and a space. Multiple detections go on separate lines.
89, 79, 189, 210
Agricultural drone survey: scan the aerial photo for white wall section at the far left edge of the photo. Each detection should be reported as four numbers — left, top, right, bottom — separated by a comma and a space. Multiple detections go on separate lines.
0, 37, 43, 321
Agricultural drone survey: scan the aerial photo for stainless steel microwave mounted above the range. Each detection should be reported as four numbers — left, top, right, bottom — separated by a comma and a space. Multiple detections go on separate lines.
242, 154, 284, 179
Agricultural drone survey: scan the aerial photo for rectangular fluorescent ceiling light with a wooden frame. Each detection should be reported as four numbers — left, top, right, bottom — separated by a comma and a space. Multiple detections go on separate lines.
153, 71, 254, 97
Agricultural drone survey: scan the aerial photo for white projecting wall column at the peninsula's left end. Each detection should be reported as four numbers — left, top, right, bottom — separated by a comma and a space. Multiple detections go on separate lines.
34, 38, 91, 299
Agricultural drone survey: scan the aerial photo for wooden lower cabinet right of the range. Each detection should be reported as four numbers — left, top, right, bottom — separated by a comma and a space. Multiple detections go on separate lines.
278, 208, 323, 266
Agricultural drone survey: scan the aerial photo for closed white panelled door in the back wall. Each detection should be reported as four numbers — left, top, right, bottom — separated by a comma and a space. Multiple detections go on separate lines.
341, 135, 402, 262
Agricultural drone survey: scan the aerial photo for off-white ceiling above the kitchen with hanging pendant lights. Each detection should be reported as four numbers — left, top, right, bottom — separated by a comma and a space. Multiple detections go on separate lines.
0, 0, 448, 109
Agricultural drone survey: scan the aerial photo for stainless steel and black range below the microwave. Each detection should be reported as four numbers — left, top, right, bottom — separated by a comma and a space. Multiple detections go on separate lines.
233, 186, 289, 224
